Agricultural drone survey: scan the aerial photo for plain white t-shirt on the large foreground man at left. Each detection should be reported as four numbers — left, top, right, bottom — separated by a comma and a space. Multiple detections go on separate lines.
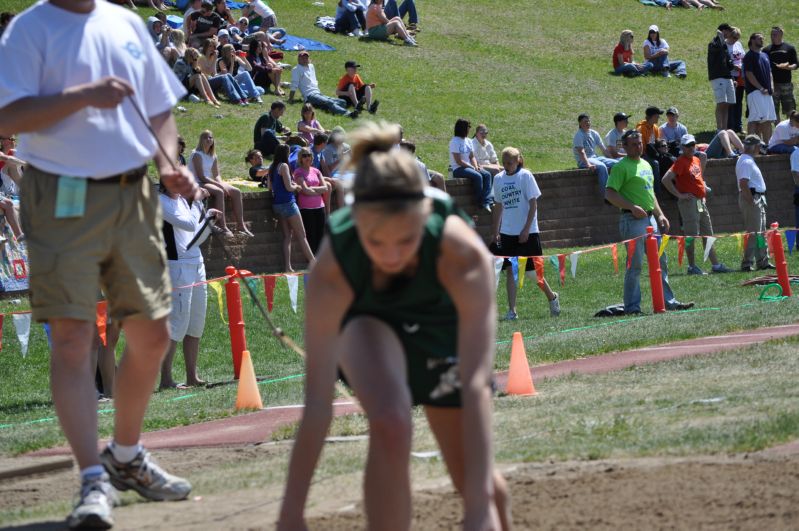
0, 0, 185, 178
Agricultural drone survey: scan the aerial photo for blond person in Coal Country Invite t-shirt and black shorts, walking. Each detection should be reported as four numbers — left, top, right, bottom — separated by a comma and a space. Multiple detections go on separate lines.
491, 147, 560, 321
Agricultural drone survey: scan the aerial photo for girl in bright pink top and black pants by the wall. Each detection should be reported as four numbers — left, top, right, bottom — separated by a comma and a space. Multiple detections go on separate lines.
294, 148, 332, 255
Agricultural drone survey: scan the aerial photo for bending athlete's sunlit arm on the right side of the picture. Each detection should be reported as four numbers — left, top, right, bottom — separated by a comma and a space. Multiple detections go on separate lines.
438, 216, 498, 529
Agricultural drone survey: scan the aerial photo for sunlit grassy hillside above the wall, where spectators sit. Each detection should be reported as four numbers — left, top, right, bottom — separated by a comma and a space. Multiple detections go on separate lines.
0, 0, 799, 178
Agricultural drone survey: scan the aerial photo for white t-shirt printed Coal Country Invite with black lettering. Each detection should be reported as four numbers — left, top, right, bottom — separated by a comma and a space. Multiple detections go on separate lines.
494, 168, 541, 236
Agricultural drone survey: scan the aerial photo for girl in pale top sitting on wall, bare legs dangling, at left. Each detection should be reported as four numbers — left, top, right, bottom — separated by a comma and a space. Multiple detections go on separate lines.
189, 129, 253, 237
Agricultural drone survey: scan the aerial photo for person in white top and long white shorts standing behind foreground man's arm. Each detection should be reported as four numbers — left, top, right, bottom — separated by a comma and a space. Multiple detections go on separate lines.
159, 185, 217, 389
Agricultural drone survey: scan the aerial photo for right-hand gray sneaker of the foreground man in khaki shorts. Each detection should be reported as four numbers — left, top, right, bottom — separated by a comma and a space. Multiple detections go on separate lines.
100, 447, 191, 501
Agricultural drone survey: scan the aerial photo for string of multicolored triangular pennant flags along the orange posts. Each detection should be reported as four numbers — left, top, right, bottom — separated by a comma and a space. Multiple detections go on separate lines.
0, 229, 799, 357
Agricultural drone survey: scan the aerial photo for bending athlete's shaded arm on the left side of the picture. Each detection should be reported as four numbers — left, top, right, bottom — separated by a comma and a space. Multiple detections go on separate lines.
278, 239, 353, 530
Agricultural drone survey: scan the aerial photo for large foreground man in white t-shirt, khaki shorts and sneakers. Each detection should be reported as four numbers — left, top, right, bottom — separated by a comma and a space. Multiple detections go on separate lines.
0, 0, 198, 529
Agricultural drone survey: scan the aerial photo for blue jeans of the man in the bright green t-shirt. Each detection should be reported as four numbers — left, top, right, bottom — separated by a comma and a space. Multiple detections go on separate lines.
619, 212, 678, 313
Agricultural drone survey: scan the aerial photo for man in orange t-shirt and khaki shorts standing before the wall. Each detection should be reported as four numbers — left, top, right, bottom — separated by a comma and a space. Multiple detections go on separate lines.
663, 134, 731, 275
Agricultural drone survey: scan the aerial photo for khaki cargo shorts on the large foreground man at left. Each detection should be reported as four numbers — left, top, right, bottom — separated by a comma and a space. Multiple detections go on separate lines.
20, 167, 171, 322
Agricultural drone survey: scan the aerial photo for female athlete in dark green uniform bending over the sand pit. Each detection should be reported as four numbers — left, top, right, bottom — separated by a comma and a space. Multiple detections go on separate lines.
278, 124, 510, 530
